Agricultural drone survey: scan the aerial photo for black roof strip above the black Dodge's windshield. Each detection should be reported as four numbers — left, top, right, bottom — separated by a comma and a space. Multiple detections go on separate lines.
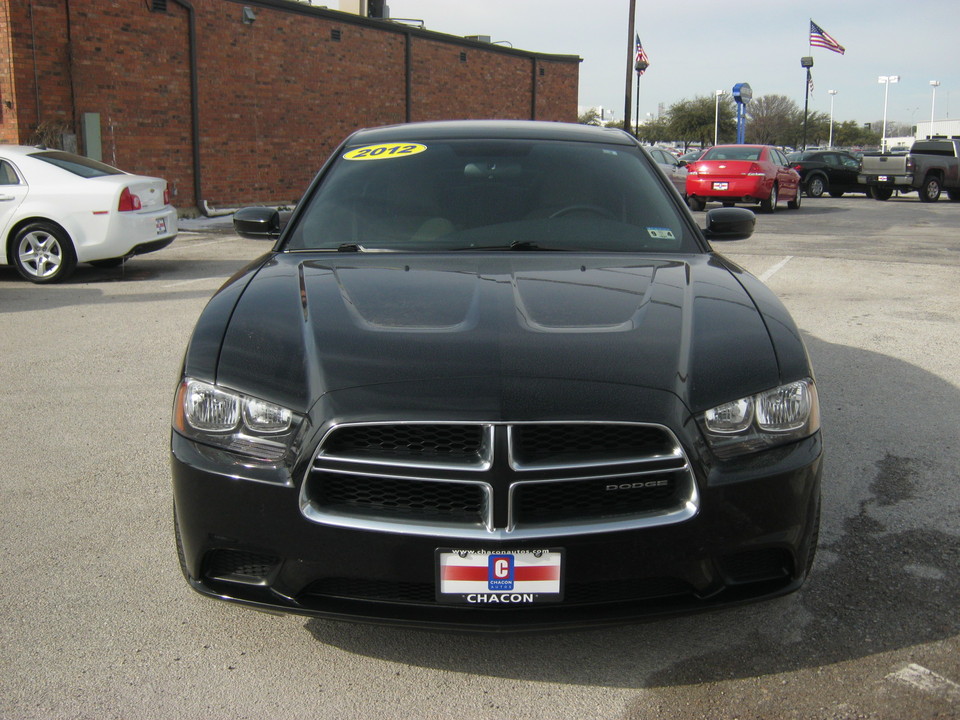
347, 120, 636, 145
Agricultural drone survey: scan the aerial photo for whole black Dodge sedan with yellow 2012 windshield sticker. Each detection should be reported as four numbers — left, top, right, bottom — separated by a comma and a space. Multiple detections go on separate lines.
172, 121, 822, 630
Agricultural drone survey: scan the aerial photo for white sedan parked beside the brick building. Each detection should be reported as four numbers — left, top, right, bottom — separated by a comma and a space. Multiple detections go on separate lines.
0, 145, 177, 283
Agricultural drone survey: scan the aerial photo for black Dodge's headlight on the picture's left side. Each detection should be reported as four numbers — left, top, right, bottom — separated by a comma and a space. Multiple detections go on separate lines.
173, 378, 302, 462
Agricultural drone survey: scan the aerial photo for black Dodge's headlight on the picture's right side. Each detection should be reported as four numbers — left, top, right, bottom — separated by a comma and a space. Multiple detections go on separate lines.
700, 379, 820, 458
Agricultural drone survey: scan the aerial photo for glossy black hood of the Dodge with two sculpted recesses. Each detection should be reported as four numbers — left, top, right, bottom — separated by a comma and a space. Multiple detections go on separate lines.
204, 252, 803, 411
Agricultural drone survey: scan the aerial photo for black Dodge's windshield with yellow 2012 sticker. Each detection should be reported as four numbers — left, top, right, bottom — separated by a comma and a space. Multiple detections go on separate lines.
285, 140, 700, 253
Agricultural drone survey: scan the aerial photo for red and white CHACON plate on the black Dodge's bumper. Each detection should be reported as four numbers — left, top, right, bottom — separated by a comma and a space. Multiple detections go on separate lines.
437, 548, 563, 607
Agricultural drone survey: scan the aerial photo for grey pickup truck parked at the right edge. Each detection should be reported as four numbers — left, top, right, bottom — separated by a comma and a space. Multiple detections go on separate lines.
857, 139, 960, 202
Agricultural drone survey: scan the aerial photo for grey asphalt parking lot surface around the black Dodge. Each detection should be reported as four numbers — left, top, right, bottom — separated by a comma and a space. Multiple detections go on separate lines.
0, 195, 960, 720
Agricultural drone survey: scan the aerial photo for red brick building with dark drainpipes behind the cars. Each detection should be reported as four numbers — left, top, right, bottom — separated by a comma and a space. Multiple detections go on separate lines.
0, 0, 580, 208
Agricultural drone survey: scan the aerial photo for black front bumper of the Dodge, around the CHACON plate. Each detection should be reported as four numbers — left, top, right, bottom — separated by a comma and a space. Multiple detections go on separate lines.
172, 433, 822, 631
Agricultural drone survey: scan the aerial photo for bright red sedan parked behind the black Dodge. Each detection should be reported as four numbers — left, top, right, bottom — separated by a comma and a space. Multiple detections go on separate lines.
687, 145, 800, 212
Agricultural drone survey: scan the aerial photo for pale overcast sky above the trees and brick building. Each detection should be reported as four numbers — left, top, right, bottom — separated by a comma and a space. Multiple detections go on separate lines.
374, 0, 960, 124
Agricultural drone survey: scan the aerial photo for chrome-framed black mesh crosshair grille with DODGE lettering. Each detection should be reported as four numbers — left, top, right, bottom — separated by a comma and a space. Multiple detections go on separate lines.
300, 421, 700, 540
